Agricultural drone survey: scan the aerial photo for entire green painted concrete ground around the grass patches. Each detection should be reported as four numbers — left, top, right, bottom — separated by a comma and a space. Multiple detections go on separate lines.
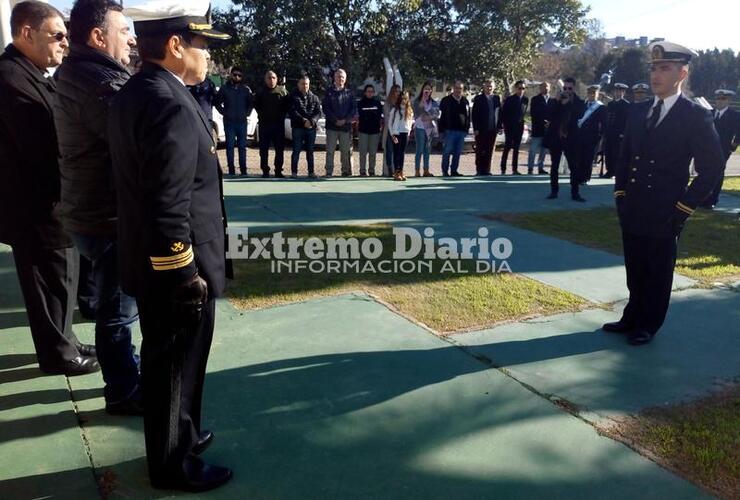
0, 179, 740, 499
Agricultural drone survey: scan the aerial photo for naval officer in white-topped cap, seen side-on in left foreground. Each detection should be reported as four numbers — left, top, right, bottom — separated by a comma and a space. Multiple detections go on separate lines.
108, 0, 232, 491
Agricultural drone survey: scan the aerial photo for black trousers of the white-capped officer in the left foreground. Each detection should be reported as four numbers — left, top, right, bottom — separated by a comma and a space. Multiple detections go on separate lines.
136, 294, 215, 481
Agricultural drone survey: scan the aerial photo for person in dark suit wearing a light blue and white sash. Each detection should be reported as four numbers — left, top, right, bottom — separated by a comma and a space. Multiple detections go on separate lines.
570, 85, 606, 202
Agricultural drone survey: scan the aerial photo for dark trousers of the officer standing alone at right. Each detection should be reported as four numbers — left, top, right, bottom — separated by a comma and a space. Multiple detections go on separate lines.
622, 232, 677, 334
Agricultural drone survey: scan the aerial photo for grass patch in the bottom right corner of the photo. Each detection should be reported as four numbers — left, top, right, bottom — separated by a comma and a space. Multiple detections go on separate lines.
605, 386, 740, 498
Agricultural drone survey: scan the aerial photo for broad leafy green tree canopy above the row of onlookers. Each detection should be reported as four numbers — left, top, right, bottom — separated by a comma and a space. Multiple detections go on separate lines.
214, 0, 587, 94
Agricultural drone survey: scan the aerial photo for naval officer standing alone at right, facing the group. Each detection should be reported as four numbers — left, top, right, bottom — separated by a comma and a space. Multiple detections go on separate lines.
603, 42, 724, 345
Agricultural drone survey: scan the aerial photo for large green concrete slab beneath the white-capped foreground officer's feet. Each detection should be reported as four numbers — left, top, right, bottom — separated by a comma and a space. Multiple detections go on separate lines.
72, 295, 704, 500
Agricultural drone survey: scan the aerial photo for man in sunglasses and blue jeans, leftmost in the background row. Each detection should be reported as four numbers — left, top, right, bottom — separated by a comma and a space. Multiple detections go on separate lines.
213, 66, 254, 175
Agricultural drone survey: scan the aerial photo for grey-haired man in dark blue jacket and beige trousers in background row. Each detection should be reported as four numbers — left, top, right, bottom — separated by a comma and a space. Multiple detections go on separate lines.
322, 69, 357, 177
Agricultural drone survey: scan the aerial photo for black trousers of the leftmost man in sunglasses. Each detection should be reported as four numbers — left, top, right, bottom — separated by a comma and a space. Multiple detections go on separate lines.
13, 243, 80, 369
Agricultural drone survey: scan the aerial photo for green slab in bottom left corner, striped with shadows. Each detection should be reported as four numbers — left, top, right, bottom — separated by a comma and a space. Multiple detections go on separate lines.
0, 326, 98, 499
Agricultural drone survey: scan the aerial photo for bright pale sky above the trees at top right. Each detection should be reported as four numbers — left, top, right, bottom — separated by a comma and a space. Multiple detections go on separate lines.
50, 0, 740, 52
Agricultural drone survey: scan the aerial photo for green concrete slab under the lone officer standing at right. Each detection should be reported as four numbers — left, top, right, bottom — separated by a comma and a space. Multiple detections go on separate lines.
454, 290, 740, 421
